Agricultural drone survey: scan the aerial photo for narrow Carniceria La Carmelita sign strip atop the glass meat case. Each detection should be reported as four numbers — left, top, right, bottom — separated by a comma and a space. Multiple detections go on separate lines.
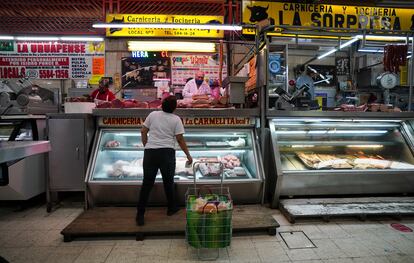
99, 117, 255, 127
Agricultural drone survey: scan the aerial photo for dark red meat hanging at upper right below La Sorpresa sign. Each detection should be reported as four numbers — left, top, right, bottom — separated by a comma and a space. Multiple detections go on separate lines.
383, 45, 408, 73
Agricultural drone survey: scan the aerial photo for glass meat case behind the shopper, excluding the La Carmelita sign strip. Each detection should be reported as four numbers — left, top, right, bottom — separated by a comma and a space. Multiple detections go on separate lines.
87, 128, 262, 207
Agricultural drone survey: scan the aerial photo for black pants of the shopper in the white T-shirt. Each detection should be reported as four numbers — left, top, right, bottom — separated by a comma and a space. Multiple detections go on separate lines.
137, 148, 176, 214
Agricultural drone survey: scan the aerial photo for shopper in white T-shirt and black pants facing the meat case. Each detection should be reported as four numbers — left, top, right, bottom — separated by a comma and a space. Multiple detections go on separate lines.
135, 96, 193, 226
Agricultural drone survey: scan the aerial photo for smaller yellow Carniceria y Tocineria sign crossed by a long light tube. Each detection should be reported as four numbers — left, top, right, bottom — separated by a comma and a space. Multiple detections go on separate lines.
106, 14, 224, 38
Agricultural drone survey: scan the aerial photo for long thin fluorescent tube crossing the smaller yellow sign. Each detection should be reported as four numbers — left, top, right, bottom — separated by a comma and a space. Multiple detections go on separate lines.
92, 23, 243, 31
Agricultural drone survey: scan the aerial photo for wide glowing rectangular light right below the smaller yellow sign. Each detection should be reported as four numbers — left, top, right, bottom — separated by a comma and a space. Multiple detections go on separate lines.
128, 41, 216, 53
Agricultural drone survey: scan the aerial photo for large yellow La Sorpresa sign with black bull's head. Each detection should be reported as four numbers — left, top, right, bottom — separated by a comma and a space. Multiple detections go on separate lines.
243, 0, 414, 34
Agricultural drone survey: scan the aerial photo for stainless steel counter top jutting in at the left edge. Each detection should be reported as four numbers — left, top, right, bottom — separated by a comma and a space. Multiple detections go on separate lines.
0, 141, 51, 163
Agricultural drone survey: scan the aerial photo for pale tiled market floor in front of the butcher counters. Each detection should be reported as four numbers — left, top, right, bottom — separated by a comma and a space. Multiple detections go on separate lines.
0, 204, 414, 263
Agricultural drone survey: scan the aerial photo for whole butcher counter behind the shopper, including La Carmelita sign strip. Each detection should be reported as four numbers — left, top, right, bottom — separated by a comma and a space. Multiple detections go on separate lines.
86, 109, 264, 206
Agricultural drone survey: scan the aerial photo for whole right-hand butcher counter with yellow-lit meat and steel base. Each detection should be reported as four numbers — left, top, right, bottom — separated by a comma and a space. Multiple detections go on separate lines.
268, 112, 414, 207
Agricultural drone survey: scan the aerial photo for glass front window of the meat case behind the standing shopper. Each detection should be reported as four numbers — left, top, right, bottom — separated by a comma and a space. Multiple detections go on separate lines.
92, 130, 257, 181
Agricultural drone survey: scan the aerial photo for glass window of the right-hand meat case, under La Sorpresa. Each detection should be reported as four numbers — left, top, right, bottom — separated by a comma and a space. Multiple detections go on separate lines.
272, 118, 414, 171
